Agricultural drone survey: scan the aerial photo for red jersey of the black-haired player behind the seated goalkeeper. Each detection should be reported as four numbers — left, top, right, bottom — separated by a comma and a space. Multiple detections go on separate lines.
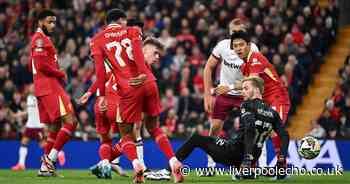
241, 52, 289, 104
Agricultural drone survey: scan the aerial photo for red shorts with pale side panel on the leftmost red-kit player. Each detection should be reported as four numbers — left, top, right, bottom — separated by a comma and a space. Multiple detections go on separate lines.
37, 89, 74, 124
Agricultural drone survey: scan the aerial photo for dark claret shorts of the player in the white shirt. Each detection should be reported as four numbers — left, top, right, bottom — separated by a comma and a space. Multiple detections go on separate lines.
211, 95, 243, 121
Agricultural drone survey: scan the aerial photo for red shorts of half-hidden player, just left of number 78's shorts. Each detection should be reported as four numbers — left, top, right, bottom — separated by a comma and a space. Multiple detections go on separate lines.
94, 94, 119, 134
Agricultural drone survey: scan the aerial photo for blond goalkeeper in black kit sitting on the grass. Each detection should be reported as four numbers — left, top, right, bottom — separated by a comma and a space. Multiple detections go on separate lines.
148, 77, 289, 179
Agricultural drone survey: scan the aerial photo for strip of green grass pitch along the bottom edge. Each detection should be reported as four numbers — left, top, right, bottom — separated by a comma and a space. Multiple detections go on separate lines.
0, 170, 350, 184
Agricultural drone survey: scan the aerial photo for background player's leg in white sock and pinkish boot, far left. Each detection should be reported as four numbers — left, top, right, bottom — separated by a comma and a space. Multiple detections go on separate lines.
11, 134, 30, 171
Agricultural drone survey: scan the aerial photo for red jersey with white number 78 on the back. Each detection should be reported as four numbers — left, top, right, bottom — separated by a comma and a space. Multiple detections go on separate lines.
90, 24, 155, 96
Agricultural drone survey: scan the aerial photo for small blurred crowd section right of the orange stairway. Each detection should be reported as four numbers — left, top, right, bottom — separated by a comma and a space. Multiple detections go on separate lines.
309, 49, 350, 139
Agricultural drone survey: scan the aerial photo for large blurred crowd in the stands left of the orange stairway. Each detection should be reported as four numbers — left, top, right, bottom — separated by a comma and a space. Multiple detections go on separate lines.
0, 0, 340, 140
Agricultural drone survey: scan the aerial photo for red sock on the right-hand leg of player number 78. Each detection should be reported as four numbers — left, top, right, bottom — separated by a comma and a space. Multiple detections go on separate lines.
149, 127, 174, 159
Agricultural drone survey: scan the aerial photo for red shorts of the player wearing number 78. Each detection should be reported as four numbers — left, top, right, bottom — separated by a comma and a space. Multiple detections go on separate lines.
117, 81, 161, 123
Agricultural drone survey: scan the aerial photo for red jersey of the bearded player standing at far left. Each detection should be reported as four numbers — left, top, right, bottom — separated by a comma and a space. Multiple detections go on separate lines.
28, 29, 65, 96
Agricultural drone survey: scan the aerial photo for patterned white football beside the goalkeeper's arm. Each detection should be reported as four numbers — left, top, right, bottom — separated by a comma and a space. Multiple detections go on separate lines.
298, 136, 321, 160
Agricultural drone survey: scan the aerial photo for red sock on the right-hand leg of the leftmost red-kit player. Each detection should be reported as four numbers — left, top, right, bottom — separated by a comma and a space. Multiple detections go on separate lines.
53, 123, 76, 151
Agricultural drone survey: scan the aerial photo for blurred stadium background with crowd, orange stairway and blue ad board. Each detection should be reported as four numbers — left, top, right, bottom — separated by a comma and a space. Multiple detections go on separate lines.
0, 0, 350, 178
